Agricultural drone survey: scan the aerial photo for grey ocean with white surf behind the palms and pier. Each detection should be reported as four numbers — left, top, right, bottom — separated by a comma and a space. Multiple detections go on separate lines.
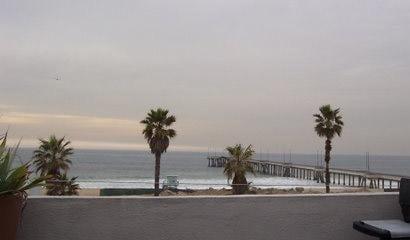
19, 148, 410, 189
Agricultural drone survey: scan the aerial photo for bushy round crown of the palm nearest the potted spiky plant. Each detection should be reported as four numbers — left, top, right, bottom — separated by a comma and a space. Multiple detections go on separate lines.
33, 135, 74, 178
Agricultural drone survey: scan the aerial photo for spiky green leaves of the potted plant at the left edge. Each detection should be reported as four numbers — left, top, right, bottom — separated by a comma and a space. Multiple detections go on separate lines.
0, 134, 47, 197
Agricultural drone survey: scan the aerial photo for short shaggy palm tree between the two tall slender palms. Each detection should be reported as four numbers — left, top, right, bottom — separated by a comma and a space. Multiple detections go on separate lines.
224, 144, 255, 194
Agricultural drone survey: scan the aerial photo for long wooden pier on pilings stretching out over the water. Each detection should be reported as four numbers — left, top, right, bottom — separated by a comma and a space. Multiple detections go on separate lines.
208, 156, 402, 190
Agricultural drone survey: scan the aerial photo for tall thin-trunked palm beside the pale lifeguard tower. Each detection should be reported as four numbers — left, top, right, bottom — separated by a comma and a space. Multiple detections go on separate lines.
141, 108, 176, 196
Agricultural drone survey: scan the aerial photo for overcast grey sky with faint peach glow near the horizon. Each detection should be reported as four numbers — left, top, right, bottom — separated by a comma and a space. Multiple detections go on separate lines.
0, 0, 410, 155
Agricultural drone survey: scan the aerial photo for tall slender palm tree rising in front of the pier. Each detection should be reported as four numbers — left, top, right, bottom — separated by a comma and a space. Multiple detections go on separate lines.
313, 105, 344, 193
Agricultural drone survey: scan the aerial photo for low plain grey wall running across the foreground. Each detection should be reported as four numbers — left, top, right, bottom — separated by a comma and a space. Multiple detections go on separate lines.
18, 193, 401, 240
